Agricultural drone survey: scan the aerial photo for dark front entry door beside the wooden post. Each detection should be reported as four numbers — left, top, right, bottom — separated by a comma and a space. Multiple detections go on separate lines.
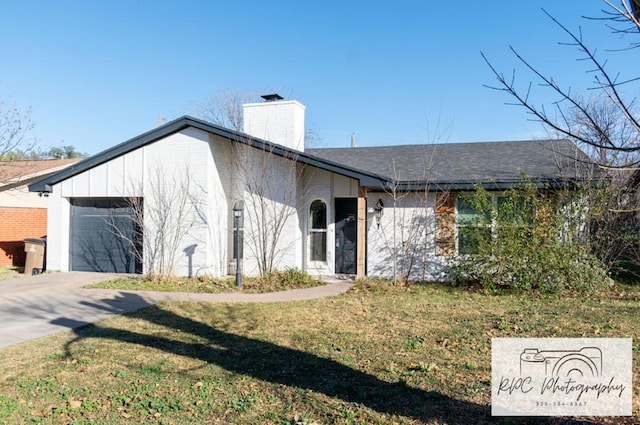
335, 198, 358, 274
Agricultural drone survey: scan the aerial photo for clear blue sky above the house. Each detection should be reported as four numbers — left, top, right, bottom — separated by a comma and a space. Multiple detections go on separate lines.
0, 0, 637, 154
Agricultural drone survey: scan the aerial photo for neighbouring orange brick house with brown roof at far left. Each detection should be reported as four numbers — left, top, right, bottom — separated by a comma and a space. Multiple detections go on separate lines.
0, 159, 79, 267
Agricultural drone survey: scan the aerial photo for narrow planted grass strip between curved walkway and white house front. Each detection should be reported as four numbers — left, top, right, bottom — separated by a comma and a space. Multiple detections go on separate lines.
86, 269, 325, 293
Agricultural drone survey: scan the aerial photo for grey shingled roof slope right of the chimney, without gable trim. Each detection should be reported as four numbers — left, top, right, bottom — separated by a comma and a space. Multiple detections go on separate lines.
306, 140, 589, 189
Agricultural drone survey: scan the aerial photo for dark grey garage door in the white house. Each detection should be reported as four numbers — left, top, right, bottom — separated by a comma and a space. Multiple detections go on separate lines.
70, 198, 142, 273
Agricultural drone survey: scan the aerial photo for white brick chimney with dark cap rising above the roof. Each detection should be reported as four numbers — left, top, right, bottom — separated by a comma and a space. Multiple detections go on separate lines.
242, 94, 305, 152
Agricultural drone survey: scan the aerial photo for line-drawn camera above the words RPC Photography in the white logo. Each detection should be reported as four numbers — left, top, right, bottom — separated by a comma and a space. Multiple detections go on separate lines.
520, 347, 602, 378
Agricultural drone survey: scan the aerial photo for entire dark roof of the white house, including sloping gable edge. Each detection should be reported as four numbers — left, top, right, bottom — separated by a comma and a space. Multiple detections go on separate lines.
29, 116, 588, 192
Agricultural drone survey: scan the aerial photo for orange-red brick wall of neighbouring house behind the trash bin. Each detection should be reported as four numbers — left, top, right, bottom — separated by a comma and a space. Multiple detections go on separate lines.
0, 208, 47, 267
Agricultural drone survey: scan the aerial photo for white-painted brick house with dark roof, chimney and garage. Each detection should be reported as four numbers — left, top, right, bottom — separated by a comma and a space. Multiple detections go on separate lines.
29, 98, 582, 279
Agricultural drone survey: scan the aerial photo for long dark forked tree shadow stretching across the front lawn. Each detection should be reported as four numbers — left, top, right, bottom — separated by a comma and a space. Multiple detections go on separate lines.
59, 298, 596, 425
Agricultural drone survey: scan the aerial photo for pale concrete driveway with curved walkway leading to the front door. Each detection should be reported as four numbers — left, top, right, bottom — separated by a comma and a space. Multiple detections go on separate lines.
0, 272, 353, 348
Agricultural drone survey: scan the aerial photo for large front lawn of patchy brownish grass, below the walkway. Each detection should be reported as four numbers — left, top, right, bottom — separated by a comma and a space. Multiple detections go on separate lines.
0, 282, 640, 425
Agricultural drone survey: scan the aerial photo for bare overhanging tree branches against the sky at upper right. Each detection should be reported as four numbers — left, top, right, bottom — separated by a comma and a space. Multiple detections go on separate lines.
482, 0, 640, 168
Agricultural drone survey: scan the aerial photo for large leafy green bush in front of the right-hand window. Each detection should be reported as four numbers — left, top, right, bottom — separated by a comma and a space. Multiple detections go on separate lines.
450, 183, 610, 293
